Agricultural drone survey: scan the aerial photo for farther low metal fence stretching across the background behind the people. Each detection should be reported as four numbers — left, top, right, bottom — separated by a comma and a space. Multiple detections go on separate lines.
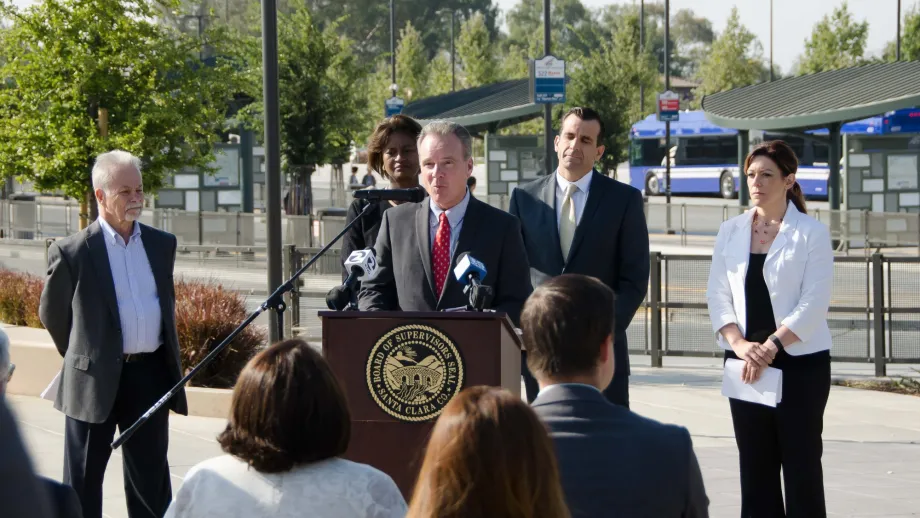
7, 195, 920, 255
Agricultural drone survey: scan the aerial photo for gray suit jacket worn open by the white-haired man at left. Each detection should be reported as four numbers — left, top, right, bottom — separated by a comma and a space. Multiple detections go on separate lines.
39, 222, 188, 423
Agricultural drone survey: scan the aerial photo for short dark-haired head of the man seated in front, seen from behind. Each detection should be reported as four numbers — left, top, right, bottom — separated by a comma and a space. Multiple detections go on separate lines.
521, 274, 615, 390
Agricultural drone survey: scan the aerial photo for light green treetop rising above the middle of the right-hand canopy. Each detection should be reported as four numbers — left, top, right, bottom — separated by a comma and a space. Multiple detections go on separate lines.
797, 2, 869, 75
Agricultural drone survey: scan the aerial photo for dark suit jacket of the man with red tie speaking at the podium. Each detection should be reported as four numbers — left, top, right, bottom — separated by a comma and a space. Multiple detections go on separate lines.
359, 197, 533, 322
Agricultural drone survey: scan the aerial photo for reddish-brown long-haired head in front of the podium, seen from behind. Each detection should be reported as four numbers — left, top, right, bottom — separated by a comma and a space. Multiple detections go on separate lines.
406, 387, 569, 518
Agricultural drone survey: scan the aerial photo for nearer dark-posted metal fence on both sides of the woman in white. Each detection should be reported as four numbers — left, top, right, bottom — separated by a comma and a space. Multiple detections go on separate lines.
627, 252, 920, 376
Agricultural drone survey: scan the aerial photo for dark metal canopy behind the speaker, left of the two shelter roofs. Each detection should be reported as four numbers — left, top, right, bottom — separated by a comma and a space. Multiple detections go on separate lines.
402, 79, 543, 135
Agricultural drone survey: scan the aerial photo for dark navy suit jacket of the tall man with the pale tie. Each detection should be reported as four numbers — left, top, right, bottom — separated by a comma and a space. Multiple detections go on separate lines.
509, 171, 649, 375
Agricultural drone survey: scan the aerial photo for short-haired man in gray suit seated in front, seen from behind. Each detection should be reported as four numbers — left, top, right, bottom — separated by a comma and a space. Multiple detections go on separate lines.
521, 274, 709, 518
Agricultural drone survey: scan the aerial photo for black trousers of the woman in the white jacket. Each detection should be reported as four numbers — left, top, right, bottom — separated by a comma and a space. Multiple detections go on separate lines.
725, 351, 831, 518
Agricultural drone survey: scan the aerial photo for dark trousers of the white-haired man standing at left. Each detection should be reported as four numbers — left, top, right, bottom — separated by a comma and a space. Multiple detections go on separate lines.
64, 354, 172, 518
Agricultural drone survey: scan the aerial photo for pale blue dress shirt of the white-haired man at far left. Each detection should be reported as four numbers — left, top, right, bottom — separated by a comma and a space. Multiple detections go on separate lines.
99, 218, 163, 354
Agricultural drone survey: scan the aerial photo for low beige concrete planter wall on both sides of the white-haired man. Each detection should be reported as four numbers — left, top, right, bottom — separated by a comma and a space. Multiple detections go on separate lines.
0, 324, 233, 419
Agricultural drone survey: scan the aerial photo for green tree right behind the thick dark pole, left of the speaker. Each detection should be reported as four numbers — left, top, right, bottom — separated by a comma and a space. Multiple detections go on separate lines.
245, 0, 367, 214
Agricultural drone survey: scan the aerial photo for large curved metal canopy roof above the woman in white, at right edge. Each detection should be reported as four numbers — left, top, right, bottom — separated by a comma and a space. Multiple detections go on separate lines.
702, 61, 920, 130
